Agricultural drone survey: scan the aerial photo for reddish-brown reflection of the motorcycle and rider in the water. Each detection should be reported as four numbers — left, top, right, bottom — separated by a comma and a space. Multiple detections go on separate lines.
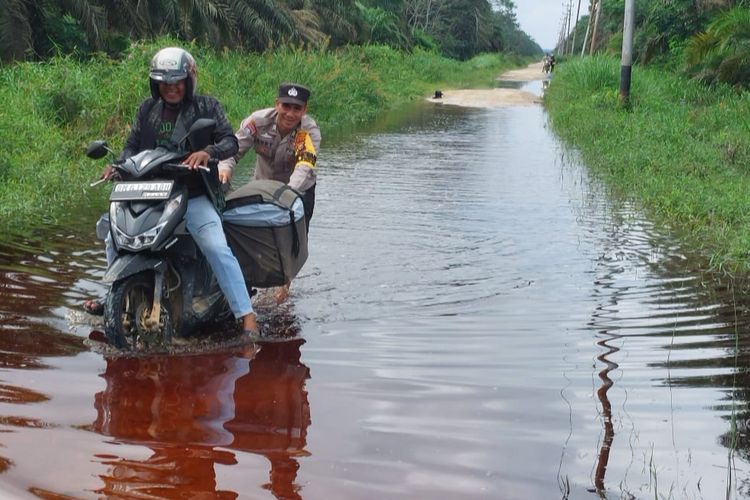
93, 339, 310, 499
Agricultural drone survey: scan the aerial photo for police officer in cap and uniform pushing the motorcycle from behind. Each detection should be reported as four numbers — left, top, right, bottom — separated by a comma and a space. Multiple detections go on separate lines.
219, 83, 320, 227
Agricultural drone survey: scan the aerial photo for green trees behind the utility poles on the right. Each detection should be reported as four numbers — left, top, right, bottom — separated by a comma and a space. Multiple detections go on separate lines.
556, 0, 750, 89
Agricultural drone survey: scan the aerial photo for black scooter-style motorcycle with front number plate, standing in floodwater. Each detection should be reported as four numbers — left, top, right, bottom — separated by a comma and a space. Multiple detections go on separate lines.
86, 118, 232, 351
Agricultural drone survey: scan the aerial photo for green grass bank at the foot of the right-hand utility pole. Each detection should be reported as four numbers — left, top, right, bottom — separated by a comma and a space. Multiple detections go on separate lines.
545, 56, 750, 274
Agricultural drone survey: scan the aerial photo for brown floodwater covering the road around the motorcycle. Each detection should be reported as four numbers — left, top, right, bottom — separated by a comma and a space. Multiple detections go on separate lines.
0, 82, 750, 500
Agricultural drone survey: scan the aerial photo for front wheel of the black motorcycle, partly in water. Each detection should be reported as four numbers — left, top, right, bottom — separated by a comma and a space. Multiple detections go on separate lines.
104, 273, 173, 351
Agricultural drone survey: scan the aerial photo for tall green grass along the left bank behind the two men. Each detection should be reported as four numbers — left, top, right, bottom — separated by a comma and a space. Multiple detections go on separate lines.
0, 38, 523, 226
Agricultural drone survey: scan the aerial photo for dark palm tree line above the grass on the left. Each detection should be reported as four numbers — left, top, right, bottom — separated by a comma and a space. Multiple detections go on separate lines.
0, 0, 542, 62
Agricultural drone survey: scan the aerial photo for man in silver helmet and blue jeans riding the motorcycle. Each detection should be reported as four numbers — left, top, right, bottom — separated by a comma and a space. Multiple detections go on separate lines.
84, 47, 258, 335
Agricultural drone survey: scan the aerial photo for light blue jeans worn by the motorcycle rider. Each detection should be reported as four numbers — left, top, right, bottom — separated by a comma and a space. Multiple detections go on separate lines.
104, 195, 253, 319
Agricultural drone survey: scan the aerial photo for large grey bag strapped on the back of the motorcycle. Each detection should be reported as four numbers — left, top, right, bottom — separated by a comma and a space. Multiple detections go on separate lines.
223, 180, 307, 288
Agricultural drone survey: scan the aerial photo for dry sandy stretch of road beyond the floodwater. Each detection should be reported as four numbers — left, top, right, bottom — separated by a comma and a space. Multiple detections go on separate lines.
427, 62, 547, 108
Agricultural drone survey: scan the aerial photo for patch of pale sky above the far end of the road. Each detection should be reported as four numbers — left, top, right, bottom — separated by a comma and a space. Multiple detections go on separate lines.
514, 0, 589, 49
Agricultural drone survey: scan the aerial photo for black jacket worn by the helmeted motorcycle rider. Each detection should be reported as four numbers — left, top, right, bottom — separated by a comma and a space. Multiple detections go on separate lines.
120, 95, 239, 210
